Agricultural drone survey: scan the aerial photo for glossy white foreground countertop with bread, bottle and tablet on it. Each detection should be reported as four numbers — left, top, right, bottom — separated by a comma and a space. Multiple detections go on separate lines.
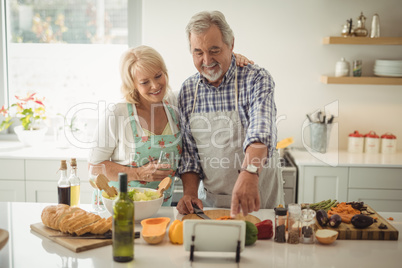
0, 202, 402, 268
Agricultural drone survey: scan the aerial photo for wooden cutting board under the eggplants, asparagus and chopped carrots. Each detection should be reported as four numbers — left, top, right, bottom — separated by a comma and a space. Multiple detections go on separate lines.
316, 206, 399, 240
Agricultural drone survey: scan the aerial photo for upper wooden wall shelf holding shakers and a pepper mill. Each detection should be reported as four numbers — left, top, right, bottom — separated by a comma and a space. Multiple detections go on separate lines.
322, 36, 402, 45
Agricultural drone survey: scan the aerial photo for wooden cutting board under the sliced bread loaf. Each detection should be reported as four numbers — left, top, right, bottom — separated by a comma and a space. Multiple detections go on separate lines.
31, 222, 113, 252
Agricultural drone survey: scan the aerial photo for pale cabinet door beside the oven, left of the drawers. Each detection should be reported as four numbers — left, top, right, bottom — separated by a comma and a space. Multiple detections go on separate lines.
299, 167, 348, 203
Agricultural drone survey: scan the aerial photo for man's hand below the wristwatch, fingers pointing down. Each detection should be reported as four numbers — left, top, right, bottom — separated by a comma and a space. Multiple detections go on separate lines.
230, 171, 260, 217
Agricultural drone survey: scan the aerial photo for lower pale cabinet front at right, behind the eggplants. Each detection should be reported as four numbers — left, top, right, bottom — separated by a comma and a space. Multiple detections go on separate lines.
349, 189, 402, 212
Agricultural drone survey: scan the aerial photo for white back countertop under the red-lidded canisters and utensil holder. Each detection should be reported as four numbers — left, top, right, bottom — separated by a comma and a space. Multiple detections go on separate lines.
289, 148, 402, 167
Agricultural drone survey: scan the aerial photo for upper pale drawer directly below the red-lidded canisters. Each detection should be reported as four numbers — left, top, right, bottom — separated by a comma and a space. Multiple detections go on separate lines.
349, 168, 402, 190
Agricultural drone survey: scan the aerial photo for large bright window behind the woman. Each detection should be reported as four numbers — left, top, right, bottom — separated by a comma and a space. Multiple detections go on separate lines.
0, 0, 141, 136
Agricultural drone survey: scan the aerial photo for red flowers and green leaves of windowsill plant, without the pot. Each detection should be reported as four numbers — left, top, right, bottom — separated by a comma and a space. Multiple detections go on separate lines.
0, 93, 46, 131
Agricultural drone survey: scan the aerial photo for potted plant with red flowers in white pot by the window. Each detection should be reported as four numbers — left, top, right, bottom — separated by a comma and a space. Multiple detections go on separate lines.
0, 93, 47, 146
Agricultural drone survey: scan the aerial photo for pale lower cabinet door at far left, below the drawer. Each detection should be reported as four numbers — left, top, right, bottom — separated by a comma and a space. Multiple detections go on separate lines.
0, 180, 25, 202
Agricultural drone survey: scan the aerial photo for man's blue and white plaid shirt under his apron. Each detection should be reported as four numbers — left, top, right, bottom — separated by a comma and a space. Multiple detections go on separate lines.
178, 55, 277, 179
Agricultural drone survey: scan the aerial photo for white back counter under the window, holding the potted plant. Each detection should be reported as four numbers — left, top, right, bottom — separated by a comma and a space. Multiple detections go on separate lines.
0, 141, 88, 160
